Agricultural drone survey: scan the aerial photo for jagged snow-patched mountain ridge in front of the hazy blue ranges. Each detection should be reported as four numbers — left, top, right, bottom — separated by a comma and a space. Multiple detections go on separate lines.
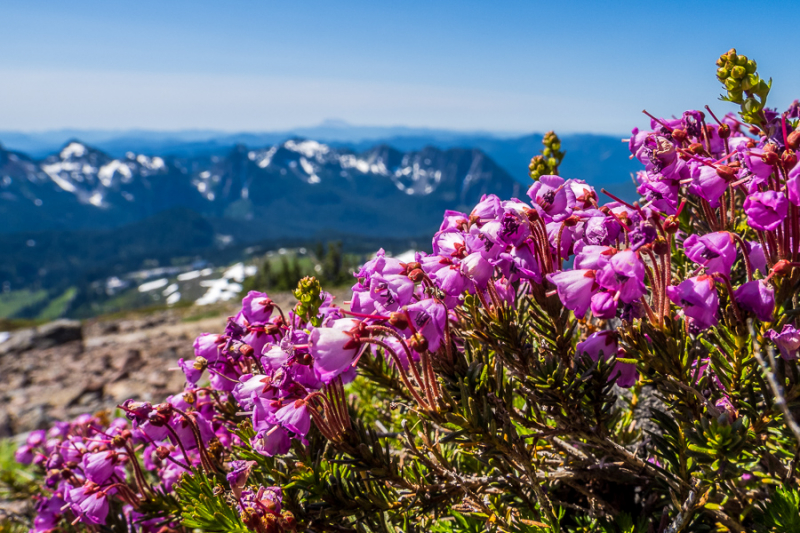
0, 139, 524, 241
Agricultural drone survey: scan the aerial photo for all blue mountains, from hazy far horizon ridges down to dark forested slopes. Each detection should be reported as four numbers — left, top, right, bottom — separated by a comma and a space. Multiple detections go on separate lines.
0, 127, 637, 318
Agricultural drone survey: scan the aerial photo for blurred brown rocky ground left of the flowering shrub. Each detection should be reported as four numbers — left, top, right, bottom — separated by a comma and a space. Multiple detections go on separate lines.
0, 288, 322, 438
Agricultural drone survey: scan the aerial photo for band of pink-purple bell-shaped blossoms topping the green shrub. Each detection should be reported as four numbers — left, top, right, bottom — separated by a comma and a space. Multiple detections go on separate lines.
17, 97, 800, 531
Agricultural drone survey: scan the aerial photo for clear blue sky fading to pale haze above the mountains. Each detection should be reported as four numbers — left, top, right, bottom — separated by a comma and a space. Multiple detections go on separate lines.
0, 0, 800, 133
